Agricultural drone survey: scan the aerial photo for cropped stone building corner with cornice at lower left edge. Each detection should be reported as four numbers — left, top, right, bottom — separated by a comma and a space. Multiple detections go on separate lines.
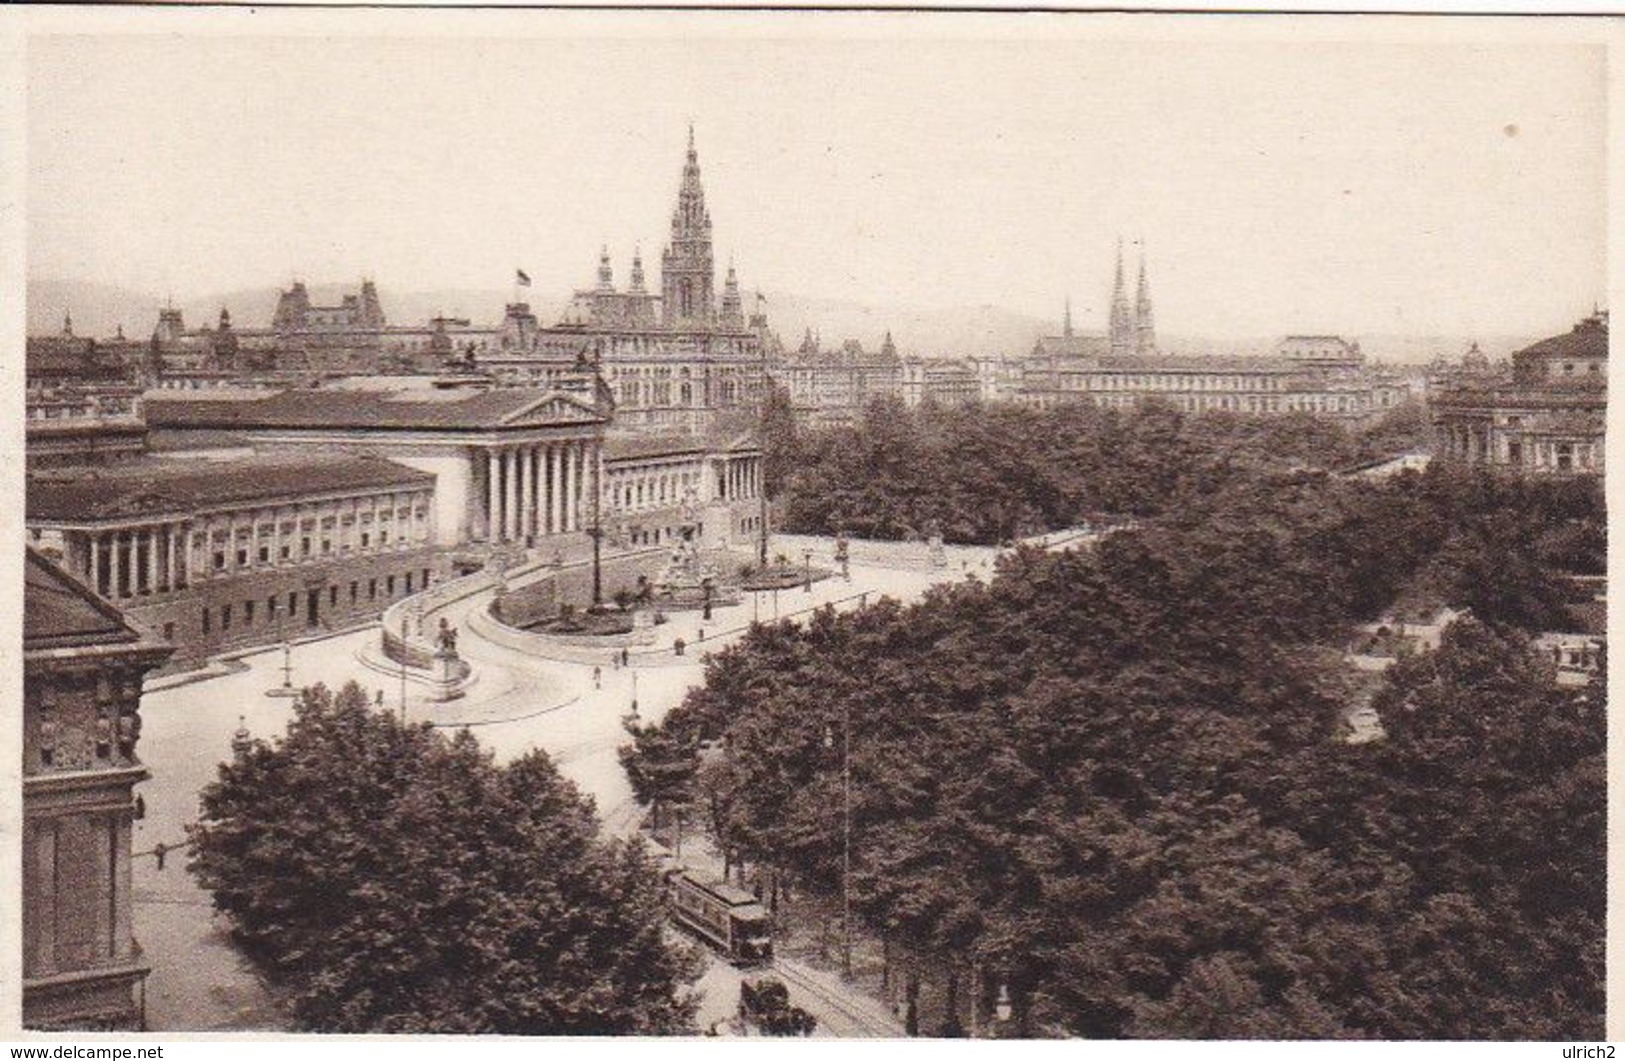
20, 549, 171, 1032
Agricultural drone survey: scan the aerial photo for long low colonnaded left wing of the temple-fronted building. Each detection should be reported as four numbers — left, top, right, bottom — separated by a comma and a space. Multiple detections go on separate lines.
28, 455, 444, 666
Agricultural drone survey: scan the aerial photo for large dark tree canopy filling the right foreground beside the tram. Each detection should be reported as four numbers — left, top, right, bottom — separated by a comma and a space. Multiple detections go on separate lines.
627, 409, 1606, 1038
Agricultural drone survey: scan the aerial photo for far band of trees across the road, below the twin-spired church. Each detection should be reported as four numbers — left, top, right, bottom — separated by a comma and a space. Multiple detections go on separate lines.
765, 400, 1424, 544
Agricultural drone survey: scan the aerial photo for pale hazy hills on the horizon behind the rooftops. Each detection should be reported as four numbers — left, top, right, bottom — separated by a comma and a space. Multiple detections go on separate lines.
28, 279, 1541, 364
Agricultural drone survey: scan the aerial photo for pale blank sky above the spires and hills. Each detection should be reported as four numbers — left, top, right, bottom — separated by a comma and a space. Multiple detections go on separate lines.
26, 13, 1607, 336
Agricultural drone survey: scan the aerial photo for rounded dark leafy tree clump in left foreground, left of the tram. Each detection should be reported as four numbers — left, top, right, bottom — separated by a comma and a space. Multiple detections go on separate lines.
190, 684, 696, 1035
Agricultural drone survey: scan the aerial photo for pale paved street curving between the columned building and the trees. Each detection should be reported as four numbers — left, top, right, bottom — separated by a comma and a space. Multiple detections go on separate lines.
133, 539, 993, 1030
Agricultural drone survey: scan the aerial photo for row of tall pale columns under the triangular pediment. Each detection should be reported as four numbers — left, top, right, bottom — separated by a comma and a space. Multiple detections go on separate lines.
484, 440, 603, 541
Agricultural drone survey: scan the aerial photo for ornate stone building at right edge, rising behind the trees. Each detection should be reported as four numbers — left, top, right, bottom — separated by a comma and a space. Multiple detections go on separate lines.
1428, 310, 1609, 474
